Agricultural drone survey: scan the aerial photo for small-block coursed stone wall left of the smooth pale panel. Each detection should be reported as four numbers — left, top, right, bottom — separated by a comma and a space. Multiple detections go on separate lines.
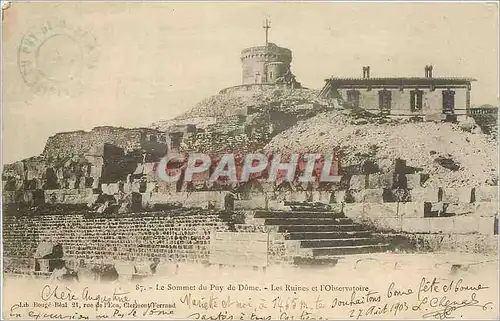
3, 210, 228, 262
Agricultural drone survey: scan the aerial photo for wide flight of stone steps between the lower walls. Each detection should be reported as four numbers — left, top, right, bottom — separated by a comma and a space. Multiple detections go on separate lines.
254, 203, 392, 260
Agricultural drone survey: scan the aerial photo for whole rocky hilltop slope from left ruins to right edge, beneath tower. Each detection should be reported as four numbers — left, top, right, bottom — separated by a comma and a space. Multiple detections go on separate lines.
3, 86, 498, 195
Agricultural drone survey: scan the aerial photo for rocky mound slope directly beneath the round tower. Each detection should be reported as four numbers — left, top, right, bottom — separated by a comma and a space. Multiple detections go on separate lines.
152, 87, 328, 153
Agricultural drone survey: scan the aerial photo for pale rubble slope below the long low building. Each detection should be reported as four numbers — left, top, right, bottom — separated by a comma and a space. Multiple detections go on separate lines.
265, 111, 498, 187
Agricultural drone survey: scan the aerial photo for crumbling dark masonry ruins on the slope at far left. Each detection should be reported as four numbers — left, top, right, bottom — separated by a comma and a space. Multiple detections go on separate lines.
2, 126, 169, 199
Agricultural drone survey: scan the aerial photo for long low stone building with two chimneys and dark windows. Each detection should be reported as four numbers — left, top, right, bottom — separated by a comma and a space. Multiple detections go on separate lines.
320, 66, 475, 120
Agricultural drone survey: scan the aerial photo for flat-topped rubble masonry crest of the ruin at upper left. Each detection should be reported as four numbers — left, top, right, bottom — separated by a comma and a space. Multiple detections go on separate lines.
43, 126, 161, 157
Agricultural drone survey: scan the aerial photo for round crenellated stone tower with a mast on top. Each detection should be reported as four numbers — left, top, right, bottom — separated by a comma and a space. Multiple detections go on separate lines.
241, 19, 296, 85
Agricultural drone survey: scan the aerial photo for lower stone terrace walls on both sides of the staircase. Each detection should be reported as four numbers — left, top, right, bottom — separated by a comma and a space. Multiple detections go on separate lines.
3, 174, 498, 269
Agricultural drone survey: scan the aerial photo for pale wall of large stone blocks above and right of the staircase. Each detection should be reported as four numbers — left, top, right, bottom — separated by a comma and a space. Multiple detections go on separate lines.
235, 184, 499, 257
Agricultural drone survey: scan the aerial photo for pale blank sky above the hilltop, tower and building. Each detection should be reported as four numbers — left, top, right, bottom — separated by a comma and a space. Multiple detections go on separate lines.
2, 2, 499, 164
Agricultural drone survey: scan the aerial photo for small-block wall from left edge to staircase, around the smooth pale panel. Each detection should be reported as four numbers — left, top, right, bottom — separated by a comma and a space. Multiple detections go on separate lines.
3, 209, 299, 273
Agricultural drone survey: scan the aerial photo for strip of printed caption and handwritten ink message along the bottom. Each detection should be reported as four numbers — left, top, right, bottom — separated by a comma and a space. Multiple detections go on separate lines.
4, 277, 496, 320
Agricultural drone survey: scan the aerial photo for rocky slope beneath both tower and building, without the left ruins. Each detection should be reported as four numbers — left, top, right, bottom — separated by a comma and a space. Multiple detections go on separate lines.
150, 88, 498, 187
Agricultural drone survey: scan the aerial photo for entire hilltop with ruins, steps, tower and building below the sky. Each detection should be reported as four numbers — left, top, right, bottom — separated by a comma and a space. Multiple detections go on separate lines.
2, 20, 498, 273
